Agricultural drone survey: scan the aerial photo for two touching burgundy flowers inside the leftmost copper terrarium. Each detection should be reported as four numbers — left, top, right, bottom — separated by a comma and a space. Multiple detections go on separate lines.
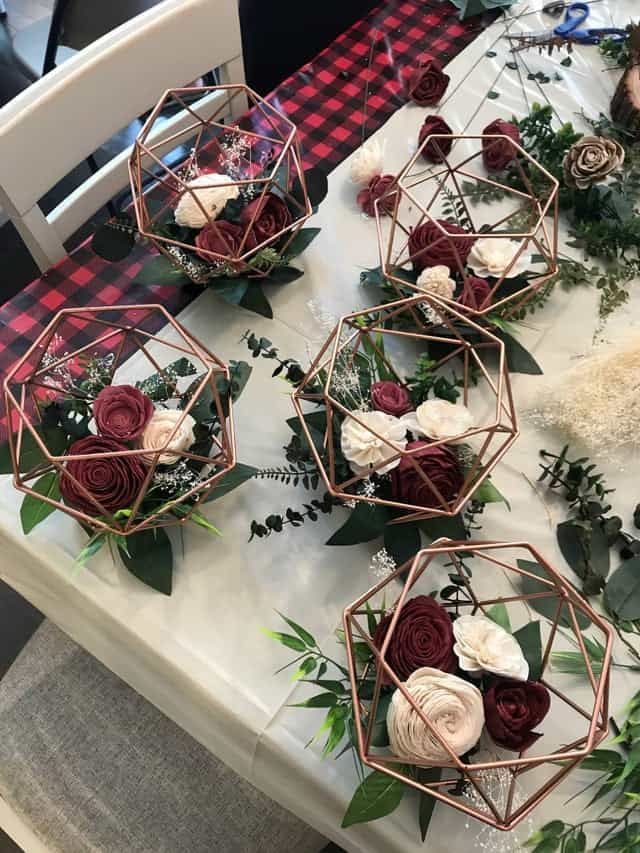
60, 385, 154, 516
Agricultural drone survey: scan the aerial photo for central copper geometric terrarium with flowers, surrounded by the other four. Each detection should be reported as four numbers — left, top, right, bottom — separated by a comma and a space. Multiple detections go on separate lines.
293, 296, 518, 522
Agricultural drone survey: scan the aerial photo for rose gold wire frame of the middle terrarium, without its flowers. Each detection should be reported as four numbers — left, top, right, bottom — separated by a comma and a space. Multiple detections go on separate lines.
292, 294, 519, 523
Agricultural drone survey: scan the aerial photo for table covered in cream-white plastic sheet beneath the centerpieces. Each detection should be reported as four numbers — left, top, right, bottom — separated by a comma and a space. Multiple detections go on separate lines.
0, 0, 640, 853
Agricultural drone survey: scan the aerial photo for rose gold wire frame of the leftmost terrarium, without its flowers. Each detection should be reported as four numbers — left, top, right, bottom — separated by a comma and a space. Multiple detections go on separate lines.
3, 304, 236, 536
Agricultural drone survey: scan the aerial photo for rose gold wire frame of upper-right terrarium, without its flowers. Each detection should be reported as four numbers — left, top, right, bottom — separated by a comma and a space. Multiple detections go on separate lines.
374, 133, 559, 319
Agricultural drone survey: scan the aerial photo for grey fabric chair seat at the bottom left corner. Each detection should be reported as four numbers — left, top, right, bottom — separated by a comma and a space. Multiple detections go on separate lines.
0, 621, 327, 853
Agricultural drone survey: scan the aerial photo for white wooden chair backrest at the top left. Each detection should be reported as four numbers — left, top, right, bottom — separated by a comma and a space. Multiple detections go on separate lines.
0, 0, 244, 271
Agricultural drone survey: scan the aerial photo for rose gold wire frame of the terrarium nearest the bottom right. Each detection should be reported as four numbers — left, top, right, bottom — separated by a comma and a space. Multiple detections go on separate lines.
343, 538, 613, 830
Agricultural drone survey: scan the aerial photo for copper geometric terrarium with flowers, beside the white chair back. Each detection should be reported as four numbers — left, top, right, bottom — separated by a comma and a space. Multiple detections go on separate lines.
129, 84, 312, 282
